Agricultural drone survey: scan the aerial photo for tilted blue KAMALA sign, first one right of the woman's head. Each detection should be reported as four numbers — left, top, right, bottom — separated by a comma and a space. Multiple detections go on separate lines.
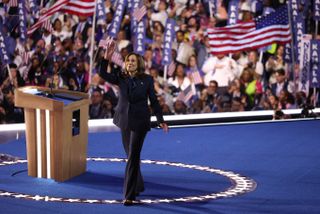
162, 18, 176, 65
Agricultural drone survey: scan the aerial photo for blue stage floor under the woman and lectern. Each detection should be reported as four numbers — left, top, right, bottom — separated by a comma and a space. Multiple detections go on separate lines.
0, 120, 320, 214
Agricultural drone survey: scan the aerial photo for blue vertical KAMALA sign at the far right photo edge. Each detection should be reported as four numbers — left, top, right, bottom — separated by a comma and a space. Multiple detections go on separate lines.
310, 40, 320, 88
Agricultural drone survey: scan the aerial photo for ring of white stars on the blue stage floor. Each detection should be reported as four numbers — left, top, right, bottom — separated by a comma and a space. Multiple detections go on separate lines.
0, 158, 257, 204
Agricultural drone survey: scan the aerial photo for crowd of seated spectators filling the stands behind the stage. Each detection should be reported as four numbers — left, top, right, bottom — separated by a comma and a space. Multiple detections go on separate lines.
0, 0, 315, 123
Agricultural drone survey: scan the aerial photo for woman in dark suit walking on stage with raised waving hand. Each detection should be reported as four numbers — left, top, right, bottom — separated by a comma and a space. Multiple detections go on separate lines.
100, 44, 168, 206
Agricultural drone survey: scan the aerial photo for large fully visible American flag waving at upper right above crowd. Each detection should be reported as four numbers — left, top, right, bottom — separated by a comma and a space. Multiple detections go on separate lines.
208, 6, 291, 54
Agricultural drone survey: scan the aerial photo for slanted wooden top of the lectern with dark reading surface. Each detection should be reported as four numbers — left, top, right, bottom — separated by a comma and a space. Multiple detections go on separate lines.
15, 86, 89, 111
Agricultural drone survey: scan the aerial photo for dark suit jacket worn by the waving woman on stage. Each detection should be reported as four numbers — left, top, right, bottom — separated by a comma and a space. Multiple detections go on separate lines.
99, 60, 164, 131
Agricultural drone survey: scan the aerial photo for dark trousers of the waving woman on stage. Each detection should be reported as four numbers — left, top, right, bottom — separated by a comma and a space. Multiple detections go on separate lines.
121, 129, 147, 200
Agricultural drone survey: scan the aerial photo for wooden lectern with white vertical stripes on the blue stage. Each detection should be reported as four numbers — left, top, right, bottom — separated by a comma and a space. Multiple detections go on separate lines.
15, 86, 89, 182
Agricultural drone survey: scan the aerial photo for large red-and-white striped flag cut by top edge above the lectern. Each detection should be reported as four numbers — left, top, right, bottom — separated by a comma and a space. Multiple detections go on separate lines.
28, 0, 95, 34
